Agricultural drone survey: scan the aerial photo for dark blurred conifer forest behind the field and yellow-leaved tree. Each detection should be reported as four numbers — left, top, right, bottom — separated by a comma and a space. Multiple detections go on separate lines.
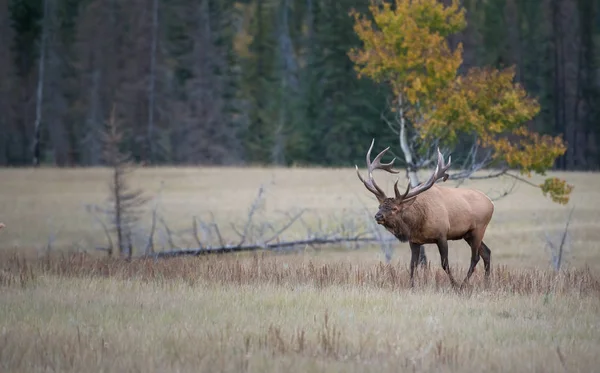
0, 0, 600, 170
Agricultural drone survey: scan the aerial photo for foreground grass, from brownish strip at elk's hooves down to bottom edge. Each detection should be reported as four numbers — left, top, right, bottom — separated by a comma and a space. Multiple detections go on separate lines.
0, 254, 600, 372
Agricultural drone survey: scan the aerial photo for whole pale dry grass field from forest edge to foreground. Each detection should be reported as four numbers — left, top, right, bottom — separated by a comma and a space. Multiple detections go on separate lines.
0, 168, 600, 373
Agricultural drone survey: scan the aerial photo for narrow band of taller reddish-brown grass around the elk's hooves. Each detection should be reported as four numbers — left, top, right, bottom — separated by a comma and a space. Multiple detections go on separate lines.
0, 253, 600, 296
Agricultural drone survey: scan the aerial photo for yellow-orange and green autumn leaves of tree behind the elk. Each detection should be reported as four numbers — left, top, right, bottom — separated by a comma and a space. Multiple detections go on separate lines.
349, 0, 573, 204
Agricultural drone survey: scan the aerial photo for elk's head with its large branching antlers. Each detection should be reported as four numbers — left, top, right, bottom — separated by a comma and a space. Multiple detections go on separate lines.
356, 139, 451, 228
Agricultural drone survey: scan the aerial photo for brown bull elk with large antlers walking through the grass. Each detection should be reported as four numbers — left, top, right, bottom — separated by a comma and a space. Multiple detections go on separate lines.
356, 139, 494, 287
